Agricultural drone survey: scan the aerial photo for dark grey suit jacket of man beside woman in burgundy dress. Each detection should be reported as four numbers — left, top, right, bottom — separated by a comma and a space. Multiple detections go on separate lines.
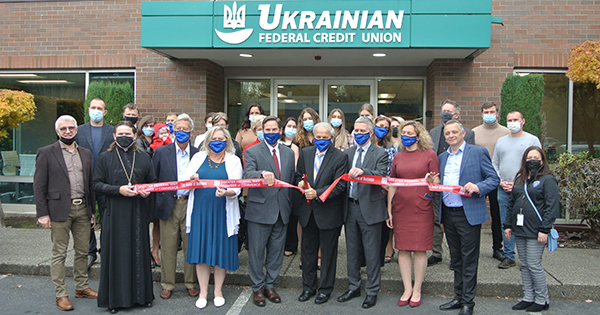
344, 143, 388, 225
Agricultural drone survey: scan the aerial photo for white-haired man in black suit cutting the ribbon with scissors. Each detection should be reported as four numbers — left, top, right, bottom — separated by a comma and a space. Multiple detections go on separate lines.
296, 122, 348, 304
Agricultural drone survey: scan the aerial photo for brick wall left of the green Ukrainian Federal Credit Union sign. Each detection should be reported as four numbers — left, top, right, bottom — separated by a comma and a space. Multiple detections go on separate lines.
0, 0, 224, 131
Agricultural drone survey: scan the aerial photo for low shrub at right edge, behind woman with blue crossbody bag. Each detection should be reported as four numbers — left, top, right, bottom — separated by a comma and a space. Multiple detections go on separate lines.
554, 152, 600, 235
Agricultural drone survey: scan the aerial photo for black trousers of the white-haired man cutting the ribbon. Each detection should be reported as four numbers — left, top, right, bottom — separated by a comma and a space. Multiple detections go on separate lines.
301, 213, 342, 295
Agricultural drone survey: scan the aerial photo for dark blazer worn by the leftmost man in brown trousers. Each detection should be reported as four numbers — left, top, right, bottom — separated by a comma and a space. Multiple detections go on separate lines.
33, 141, 96, 222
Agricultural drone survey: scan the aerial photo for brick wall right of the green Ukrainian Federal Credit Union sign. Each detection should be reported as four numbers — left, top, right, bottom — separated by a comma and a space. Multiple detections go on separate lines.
427, 0, 600, 128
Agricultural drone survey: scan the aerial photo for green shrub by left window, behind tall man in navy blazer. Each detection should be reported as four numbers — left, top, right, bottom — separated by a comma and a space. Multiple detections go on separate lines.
84, 80, 134, 125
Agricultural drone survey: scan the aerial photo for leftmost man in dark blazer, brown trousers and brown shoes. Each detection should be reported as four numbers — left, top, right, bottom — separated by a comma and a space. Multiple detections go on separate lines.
33, 115, 98, 311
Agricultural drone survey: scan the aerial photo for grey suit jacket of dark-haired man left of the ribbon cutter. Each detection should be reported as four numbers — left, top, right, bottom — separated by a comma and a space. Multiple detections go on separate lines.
244, 141, 297, 224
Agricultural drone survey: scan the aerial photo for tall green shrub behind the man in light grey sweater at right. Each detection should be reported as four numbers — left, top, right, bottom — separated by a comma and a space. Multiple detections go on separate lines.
500, 74, 545, 143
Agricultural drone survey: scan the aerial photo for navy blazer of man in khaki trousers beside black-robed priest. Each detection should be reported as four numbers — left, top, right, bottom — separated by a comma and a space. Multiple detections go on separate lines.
152, 142, 198, 220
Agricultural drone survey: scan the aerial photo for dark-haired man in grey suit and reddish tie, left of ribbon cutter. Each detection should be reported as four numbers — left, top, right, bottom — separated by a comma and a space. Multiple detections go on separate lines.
244, 116, 294, 306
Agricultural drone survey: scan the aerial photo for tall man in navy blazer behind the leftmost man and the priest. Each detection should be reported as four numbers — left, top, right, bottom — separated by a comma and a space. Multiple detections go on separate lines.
76, 98, 115, 268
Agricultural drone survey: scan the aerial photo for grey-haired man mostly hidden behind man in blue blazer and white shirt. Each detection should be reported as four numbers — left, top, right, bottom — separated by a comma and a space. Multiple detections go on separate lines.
427, 100, 475, 266
